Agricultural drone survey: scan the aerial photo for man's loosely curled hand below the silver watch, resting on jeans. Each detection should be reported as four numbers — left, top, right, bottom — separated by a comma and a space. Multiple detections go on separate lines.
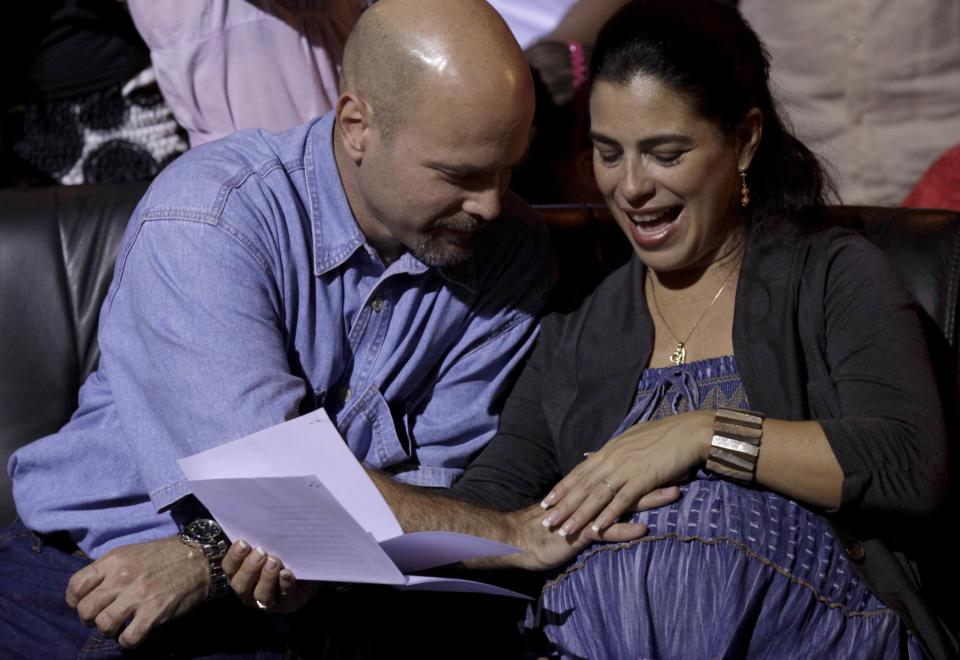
67, 536, 210, 648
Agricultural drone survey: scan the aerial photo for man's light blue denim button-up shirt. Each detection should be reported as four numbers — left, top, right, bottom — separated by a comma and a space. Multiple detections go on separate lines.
8, 114, 550, 557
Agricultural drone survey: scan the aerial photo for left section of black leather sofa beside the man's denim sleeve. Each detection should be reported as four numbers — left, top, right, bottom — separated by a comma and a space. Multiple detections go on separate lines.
0, 184, 146, 524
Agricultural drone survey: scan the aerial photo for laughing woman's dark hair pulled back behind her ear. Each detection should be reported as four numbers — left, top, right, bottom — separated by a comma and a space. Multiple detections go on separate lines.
590, 0, 833, 238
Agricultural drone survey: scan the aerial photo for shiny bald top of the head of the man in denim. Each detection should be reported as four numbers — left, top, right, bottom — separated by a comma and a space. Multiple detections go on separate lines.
340, 0, 533, 141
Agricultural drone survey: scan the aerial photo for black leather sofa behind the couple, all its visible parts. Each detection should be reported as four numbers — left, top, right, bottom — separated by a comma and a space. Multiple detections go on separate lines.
0, 184, 960, 523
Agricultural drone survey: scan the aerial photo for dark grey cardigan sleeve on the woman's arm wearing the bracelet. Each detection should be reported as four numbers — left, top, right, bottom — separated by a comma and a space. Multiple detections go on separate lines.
808, 237, 947, 516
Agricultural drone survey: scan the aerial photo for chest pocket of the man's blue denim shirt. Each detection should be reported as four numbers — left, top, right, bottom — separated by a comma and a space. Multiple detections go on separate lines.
338, 385, 411, 469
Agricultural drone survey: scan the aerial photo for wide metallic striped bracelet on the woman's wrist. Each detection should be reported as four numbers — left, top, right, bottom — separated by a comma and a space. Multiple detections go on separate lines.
707, 408, 766, 481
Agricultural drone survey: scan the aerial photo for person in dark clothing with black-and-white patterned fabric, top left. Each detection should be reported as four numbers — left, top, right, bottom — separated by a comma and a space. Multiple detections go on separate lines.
0, 0, 187, 185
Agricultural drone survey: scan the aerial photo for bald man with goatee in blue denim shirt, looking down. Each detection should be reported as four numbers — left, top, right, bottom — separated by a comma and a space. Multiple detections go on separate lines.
0, 0, 549, 657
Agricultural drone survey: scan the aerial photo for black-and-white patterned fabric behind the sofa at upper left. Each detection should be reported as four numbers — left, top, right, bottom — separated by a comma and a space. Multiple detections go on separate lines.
12, 68, 187, 185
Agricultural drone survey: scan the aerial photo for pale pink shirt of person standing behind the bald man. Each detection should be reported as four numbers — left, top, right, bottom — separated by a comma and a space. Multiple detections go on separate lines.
128, 0, 368, 147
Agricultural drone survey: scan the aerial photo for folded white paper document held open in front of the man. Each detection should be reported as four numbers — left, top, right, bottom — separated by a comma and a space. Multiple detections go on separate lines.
178, 410, 526, 598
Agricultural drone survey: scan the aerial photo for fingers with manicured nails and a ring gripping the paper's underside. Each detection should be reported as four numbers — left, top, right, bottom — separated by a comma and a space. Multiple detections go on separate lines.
223, 540, 319, 612
